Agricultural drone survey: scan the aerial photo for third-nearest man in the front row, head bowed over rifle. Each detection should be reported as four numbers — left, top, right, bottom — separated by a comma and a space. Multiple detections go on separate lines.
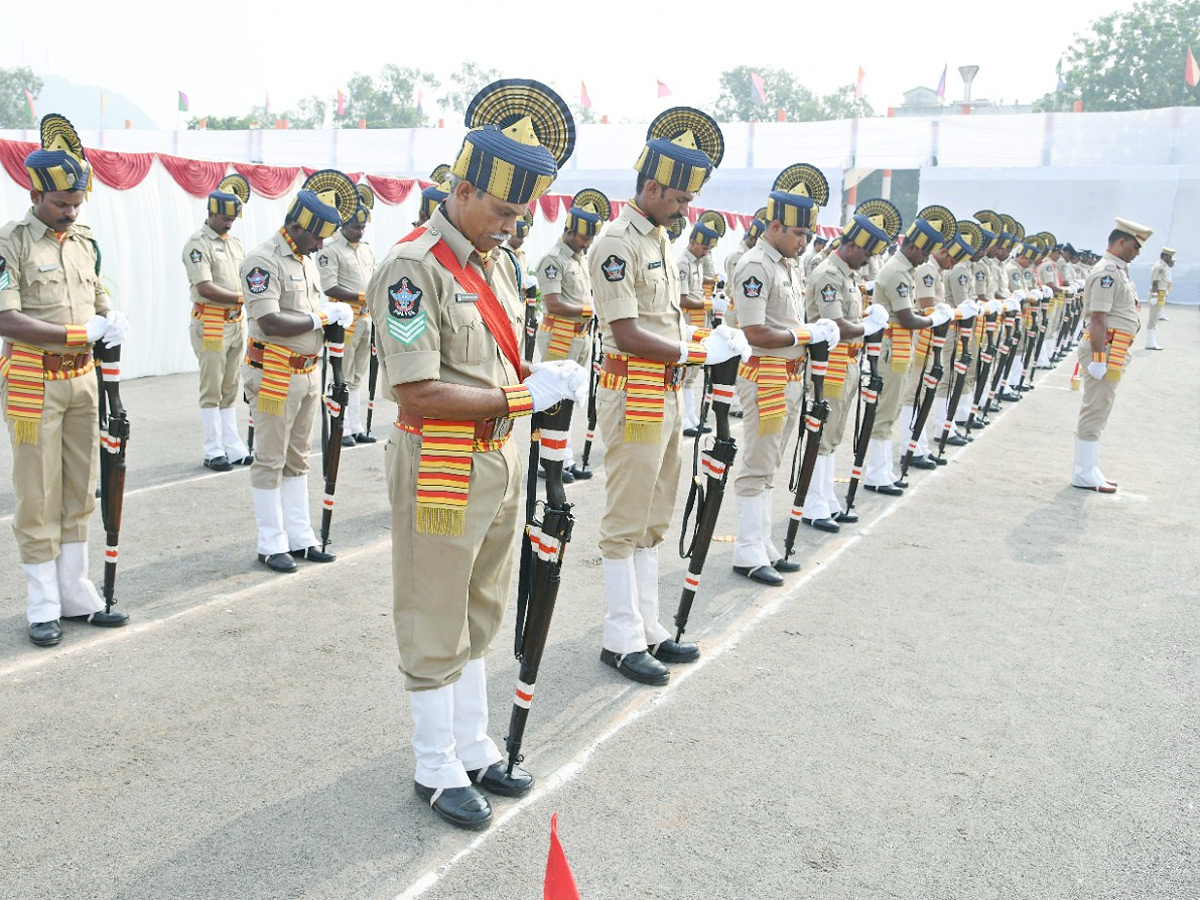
731, 163, 839, 587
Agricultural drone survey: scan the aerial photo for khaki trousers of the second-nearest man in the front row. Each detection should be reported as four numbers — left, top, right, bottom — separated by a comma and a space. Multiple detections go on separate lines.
596, 388, 683, 559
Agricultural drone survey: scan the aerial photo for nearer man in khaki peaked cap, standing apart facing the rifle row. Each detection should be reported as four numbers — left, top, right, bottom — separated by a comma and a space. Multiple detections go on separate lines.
1070, 218, 1154, 493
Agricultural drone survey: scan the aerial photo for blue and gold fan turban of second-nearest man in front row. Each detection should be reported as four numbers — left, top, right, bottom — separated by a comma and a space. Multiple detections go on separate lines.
634, 107, 725, 193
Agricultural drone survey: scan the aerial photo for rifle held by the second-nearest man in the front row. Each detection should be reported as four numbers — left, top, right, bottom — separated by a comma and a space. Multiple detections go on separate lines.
674, 356, 742, 641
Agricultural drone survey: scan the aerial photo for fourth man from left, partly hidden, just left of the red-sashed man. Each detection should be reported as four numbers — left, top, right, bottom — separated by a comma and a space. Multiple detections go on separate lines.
317, 185, 376, 446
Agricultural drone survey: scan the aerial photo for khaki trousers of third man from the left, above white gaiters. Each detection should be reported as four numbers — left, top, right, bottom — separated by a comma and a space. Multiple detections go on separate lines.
241, 365, 320, 491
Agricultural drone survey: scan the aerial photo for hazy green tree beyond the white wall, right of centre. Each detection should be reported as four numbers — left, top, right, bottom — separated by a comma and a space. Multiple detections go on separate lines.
713, 66, 875, 122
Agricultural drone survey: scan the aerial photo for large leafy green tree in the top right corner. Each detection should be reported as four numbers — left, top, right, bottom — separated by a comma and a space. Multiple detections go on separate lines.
1038, 0, 1200, 113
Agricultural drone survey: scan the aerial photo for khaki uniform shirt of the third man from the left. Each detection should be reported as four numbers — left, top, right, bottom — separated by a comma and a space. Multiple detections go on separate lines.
241, 232, 324, 356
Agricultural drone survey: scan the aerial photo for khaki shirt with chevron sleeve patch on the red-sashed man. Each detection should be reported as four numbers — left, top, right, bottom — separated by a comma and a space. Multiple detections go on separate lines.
367, 208, 524, 388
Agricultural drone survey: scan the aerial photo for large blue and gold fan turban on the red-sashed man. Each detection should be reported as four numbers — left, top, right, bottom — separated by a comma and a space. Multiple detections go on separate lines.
452, 78, 575, 203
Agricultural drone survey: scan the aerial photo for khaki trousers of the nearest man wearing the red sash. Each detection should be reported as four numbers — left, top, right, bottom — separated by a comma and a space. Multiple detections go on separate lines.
384, 427, 521, 691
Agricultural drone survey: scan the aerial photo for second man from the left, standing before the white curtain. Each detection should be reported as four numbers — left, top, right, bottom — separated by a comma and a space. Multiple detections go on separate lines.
184, 175, 253, 472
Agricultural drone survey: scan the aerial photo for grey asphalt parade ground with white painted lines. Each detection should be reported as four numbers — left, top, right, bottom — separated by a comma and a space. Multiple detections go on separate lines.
0, 307, 1200, 900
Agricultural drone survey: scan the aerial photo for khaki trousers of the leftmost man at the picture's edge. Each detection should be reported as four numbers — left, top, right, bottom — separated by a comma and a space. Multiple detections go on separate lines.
0, 372, 100, 565
